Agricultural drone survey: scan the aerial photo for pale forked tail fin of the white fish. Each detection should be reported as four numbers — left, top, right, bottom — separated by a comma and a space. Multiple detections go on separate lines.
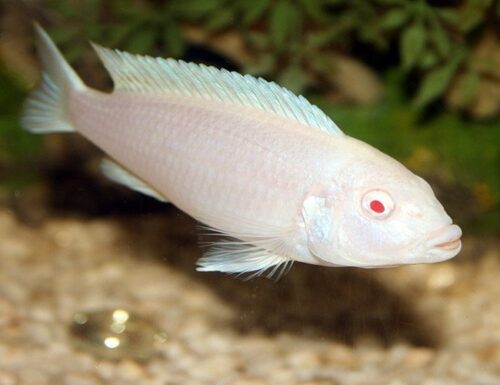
21, 23, 86, 133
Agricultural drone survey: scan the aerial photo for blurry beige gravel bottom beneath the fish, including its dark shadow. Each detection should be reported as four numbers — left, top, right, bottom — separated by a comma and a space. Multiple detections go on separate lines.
0, 209, 500, 385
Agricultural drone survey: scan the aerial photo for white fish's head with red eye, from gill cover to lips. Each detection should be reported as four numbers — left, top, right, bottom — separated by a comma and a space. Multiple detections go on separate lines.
300, 140, 462, 268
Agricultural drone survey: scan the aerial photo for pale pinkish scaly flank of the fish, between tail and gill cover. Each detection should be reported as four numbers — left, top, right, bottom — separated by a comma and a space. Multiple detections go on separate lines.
70, 93, 324, 232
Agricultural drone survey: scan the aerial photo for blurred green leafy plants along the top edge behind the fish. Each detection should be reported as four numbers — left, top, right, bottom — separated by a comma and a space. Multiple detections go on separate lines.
48, 0, 500, 103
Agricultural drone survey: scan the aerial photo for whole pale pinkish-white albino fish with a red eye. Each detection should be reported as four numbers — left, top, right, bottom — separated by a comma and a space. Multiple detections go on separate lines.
22, 26, 462, 276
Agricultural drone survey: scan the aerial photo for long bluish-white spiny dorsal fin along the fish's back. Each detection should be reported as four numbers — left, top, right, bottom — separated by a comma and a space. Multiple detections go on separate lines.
92, 44, 343, 135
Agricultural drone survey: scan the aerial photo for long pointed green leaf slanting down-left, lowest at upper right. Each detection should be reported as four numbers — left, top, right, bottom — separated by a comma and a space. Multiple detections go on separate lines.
414, 51, 465, 108
